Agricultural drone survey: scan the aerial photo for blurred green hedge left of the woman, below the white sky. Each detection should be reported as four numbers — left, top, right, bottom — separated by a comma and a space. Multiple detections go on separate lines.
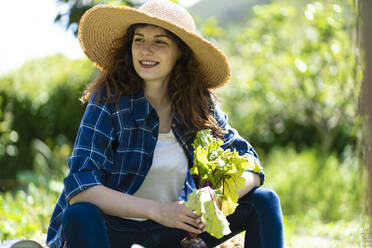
0, 55, 95, 188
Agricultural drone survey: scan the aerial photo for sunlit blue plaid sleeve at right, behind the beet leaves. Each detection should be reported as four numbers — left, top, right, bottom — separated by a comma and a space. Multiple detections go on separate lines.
214, 104, 265, 185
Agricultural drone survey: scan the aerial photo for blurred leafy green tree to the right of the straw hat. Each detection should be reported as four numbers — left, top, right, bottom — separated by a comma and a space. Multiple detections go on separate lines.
217, 2, 362, 154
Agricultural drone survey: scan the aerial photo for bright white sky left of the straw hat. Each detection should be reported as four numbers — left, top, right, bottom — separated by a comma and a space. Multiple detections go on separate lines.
0, 0, 82, 73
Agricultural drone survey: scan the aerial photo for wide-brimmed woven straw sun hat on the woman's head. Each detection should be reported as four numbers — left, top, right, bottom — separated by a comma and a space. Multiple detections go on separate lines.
78, 0, 230, 88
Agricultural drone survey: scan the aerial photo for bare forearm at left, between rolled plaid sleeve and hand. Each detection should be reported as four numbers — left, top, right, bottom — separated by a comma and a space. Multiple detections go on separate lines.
70, 185, 160, 219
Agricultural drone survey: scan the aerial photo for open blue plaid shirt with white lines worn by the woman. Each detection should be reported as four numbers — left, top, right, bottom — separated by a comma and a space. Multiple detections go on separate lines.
47, 91, 264, 248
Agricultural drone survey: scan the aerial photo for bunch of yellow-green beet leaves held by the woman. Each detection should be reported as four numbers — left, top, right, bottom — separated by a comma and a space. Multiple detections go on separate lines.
185, 129, 261, 238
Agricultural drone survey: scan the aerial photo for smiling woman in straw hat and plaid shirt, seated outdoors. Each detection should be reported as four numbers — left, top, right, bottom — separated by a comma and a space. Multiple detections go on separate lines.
47, 0, 283, 248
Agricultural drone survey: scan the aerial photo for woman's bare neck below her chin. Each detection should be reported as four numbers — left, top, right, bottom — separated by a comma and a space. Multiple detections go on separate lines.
144, 81, 170, 110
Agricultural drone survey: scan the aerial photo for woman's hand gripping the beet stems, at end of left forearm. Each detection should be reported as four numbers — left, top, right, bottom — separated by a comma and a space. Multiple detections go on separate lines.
151, 201, 205, 234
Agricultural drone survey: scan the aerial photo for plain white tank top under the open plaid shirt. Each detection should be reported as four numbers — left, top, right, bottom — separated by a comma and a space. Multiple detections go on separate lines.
128, 130, 188, 220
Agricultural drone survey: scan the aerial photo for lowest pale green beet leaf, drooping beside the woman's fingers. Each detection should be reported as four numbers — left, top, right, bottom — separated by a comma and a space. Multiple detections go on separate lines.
185, 187, 231, 238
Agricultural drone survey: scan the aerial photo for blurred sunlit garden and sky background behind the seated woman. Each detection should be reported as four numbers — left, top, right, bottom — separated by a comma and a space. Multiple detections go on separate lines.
0, 0, 370, 248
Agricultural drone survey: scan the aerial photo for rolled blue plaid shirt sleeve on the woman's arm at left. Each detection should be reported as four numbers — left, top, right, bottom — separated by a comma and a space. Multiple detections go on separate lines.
64, 94, 114, 202
